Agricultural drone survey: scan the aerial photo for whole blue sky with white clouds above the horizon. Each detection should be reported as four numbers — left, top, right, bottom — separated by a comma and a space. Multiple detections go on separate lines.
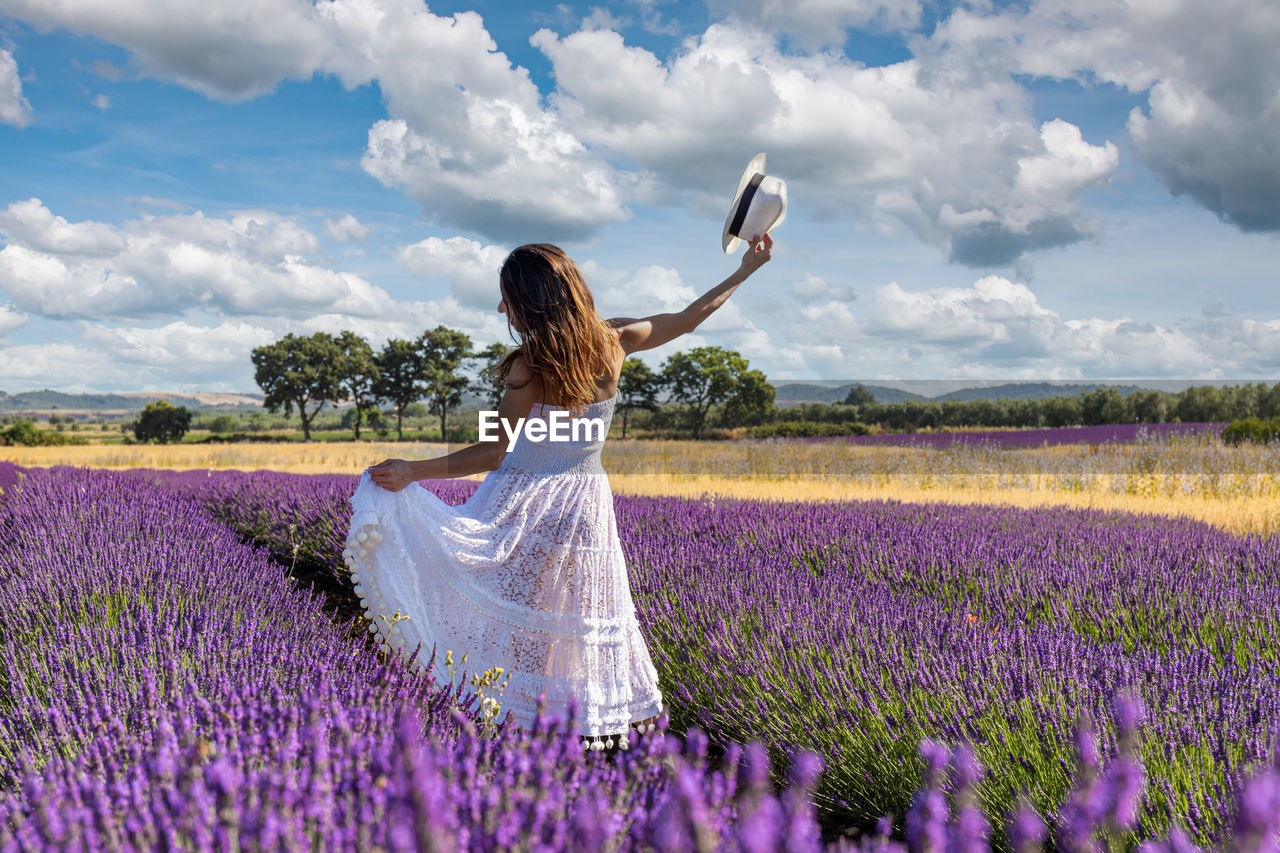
0, 0, 1280, 393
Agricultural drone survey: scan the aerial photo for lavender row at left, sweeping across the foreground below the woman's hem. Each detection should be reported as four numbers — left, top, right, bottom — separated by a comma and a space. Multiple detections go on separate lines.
0, 469, 822, 850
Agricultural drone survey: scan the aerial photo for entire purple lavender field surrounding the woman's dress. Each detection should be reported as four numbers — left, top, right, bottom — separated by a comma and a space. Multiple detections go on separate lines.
0, 465, 1280, 850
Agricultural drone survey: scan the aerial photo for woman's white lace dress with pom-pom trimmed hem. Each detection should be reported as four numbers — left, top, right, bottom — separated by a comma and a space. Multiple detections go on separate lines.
344, 394, 664, 742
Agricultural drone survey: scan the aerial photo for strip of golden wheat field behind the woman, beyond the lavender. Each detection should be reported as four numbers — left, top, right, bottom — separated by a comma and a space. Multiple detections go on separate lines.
0, 437, 1280, 533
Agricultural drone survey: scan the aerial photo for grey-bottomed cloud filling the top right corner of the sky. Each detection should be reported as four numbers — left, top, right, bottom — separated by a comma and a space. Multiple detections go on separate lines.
913, 0, 1280, 231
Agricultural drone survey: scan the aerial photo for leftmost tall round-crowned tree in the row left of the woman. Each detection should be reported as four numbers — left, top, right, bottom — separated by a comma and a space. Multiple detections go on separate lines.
252, 332, 342, 441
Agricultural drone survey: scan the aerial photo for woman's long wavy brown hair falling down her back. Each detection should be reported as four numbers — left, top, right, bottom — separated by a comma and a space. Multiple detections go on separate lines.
489, 243, 618, 415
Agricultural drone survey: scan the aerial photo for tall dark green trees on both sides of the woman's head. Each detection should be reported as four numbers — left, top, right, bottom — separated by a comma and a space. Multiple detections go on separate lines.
251, 325, 773, 441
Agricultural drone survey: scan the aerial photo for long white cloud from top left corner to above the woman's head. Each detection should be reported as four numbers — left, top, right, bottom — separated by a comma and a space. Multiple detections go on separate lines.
0, 0, 630, 240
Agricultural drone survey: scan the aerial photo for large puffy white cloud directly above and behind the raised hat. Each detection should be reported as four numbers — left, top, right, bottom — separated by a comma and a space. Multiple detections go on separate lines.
532, 24, 1119, 265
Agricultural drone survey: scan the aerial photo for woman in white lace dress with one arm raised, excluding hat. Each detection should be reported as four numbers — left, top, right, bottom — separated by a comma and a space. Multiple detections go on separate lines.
344, 234, 773, 749
